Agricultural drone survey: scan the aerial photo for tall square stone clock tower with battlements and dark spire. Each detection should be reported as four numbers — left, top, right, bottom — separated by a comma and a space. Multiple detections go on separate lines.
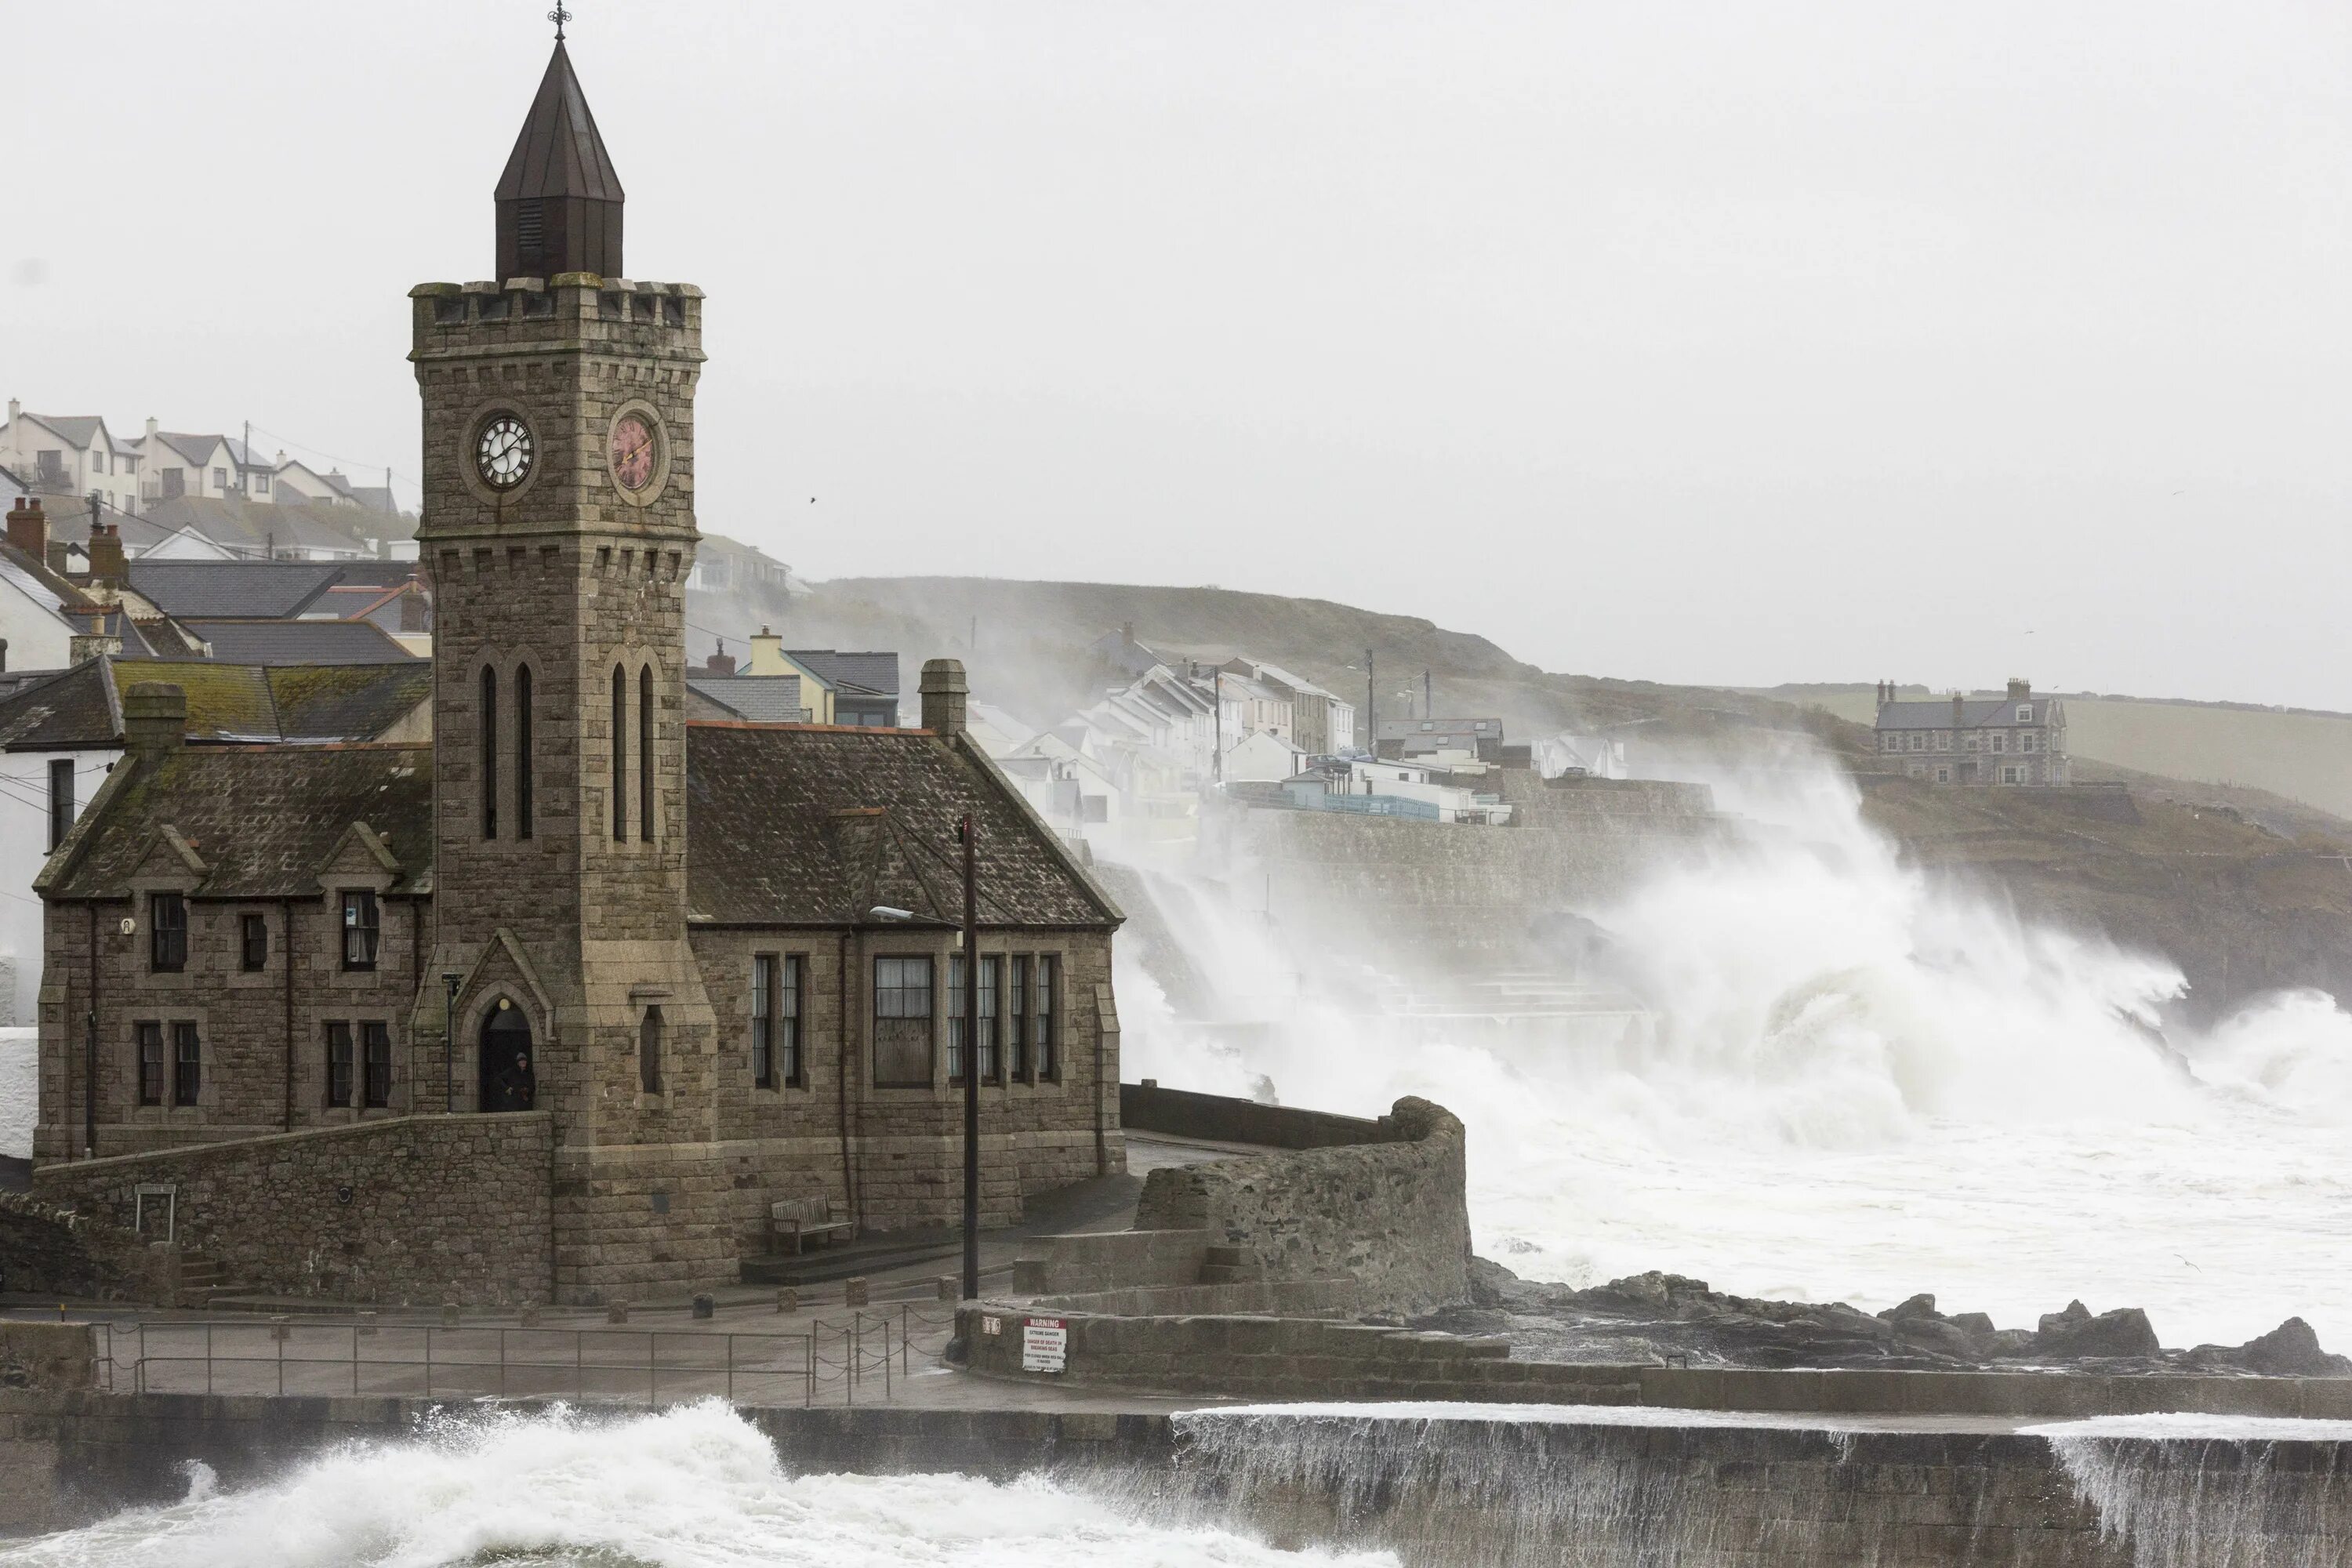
409, 40, 720, 1300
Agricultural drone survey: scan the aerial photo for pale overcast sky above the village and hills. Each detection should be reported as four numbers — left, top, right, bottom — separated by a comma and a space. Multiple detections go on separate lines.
0, 0, 2352, 708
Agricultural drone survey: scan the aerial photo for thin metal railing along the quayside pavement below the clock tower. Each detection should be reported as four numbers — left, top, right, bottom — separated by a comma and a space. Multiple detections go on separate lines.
99, 1305, 953, 1406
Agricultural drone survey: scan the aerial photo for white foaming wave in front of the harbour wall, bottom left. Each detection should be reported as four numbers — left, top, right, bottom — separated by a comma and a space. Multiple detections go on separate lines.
0, 1403, 1395, 1568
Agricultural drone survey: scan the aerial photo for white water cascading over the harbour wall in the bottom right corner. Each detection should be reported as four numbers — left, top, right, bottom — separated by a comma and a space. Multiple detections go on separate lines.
2027, 1415, 2352, 1568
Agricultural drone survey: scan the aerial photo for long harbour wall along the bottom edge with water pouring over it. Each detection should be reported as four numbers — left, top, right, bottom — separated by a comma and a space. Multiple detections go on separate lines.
0, 1389, 2352, 1568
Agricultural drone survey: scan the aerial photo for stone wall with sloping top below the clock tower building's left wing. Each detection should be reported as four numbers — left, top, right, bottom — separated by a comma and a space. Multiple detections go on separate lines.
33, 1112, 553, 1305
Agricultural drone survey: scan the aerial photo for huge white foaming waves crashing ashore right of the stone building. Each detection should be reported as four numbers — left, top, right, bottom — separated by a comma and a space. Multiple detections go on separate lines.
1117, 757, 2352, 1349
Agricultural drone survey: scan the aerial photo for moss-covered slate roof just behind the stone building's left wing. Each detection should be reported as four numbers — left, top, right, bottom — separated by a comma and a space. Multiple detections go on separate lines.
0, 659, 433, 753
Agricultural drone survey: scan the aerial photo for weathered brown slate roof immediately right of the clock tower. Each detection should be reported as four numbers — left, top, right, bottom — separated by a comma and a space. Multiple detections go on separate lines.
687, 724, 1122, 926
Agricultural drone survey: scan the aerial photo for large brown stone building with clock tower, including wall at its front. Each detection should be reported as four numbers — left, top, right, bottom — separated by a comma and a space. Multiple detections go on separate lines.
33, 42, 1124, 1302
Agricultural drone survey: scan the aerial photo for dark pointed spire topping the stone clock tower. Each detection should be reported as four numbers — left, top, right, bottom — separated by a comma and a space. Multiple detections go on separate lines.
496, 42, 626, 282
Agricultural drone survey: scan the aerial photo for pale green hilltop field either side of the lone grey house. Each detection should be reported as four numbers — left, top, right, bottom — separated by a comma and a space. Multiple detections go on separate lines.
1757, 687, 2352, 815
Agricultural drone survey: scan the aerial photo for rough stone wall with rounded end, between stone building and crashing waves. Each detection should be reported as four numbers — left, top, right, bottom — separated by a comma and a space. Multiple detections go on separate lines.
1122, 1098, 1470, 1314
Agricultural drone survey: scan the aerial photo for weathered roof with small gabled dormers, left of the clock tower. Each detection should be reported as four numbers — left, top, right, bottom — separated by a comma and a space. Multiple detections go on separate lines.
33, 746, 433, 898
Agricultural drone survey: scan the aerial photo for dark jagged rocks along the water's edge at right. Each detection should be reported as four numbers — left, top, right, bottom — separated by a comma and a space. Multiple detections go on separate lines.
1414, 1258, 2352, 1377
